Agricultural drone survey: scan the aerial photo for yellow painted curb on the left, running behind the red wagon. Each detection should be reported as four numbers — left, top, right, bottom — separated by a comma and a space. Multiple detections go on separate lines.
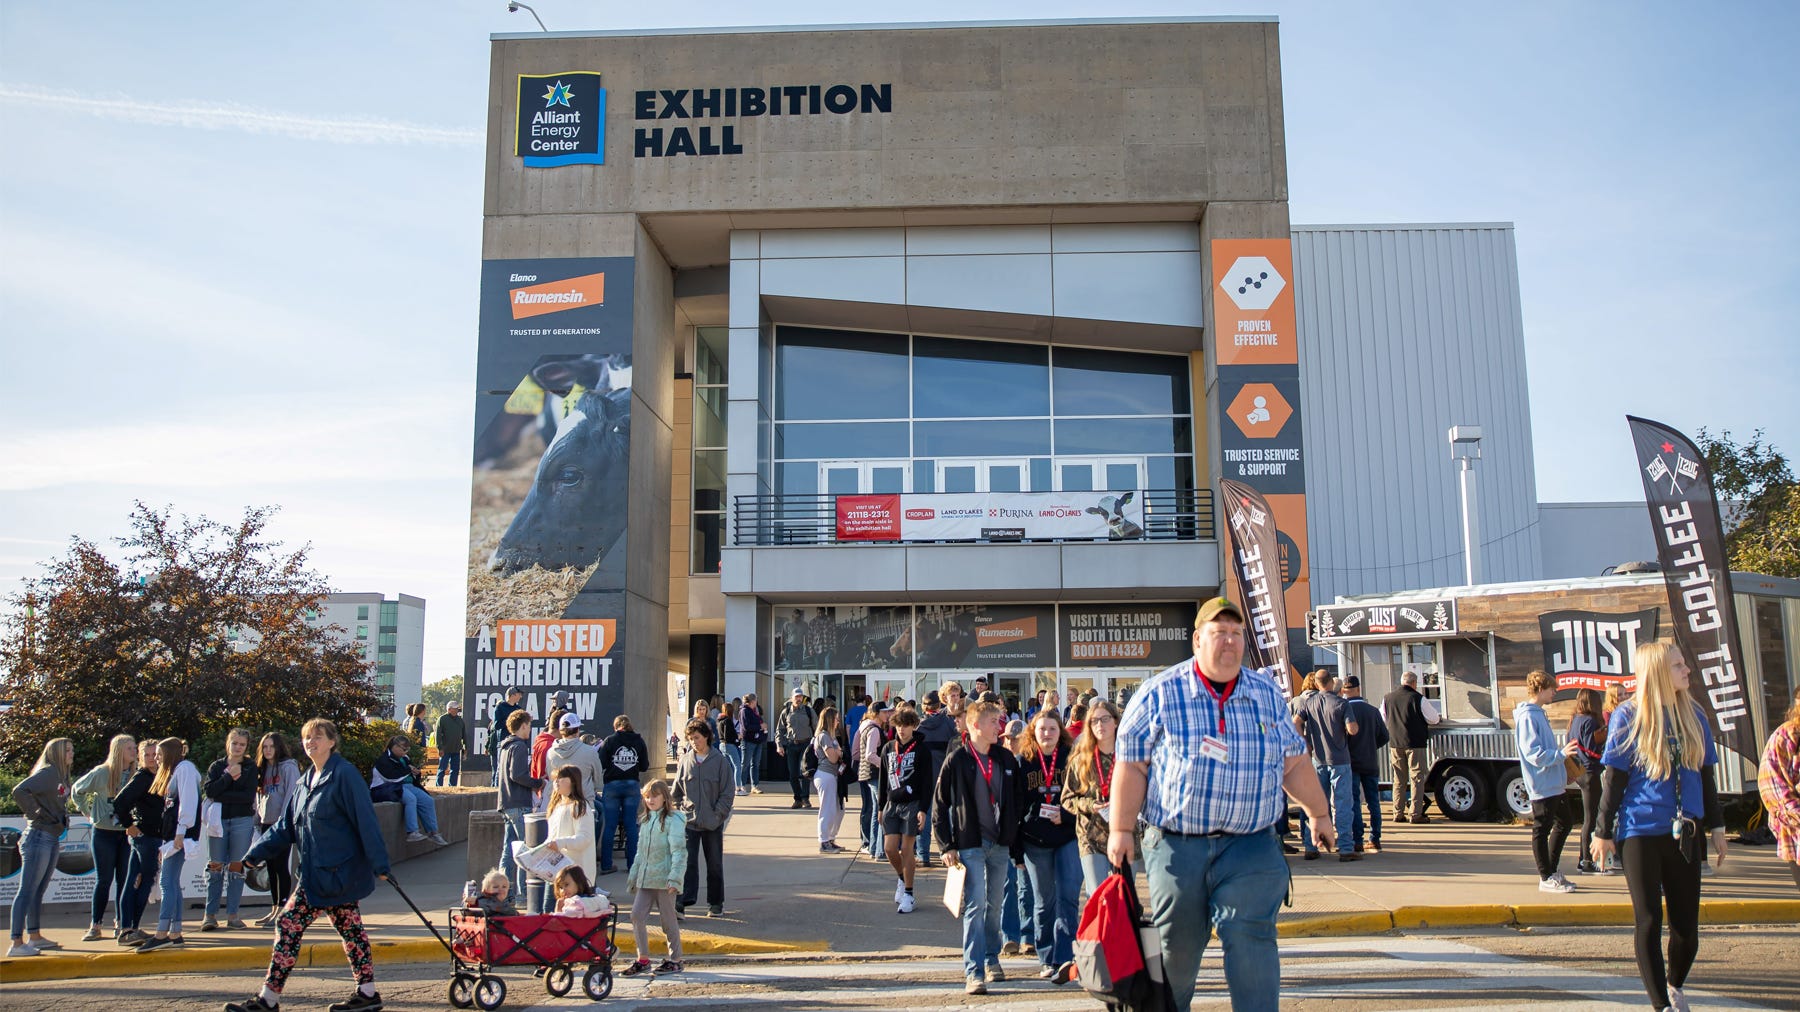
0, 926, 830, 983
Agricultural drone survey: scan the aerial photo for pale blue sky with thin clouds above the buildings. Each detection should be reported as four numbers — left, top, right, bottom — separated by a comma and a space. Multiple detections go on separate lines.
0, 0, 1800, 681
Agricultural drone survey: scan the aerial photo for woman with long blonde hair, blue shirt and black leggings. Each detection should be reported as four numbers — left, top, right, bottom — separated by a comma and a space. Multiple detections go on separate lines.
1593, 643, 1724, 1012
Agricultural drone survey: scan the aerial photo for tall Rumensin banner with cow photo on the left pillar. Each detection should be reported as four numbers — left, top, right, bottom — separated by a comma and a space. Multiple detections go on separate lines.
463, 258, 634, 754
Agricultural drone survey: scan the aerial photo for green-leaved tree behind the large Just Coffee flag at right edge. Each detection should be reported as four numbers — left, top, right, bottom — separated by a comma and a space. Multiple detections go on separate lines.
1696, 429, 1800, 576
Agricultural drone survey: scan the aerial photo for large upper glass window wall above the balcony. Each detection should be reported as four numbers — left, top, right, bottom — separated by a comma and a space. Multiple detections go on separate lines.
774, 326, 1193, 497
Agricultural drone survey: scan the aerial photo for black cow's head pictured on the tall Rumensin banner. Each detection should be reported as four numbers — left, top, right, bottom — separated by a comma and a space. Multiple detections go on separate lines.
488, 367, 632, 574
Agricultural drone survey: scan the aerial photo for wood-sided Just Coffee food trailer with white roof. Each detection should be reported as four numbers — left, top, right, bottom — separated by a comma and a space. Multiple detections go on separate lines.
1307, 573, 1800, 821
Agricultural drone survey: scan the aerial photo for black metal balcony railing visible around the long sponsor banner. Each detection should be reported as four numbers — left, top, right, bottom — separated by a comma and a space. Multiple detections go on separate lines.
731, 488, 1215, 547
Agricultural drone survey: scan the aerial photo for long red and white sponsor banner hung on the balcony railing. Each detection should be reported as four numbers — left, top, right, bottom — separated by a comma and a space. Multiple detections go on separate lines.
837, 492, 1143, 542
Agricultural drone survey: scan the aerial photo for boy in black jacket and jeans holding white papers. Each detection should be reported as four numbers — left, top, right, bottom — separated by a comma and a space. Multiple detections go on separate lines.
932, 691, 1024, 994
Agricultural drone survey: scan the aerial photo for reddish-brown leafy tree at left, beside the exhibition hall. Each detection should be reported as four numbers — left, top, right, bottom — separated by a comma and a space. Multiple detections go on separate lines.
0, 502, 382, 764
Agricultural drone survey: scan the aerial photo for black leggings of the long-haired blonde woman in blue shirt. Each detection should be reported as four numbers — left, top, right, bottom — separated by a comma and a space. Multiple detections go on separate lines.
1618, 834, 1706, 1008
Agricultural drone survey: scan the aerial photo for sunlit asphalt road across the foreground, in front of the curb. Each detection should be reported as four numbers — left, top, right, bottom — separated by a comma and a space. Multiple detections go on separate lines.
0, 926, 1800, 1012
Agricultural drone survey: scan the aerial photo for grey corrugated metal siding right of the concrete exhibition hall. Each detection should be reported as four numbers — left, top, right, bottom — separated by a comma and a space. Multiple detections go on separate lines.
1292, 225, 1541, 603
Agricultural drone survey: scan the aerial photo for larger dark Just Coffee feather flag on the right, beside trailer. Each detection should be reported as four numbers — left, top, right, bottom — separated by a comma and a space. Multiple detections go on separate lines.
1625, 414, 1760, 758
